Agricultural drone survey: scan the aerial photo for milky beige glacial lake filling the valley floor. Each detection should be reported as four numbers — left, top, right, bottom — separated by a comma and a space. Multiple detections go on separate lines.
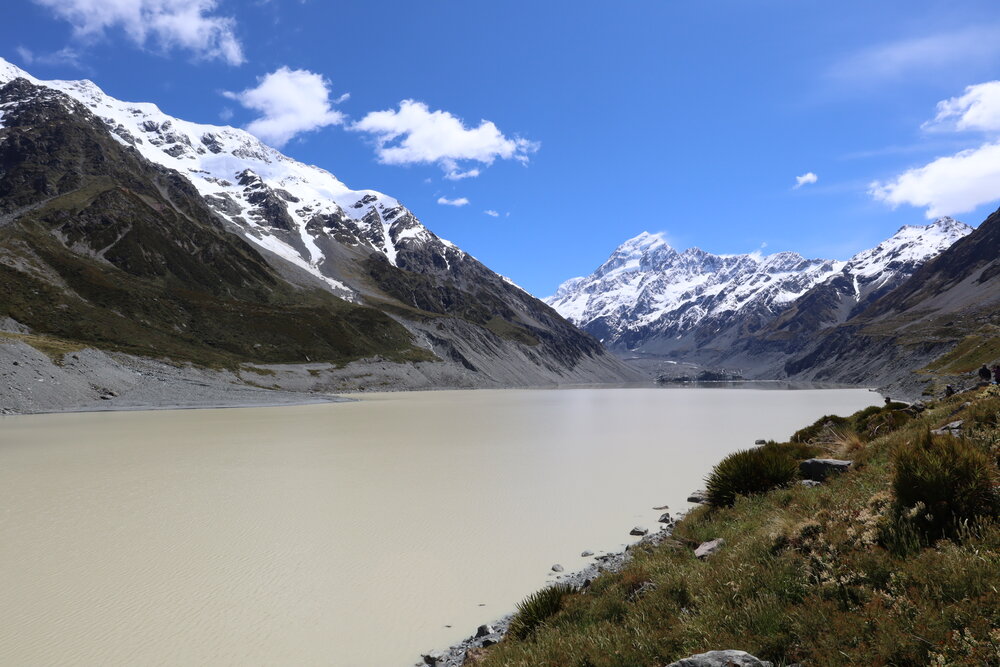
0, 389, 880, 667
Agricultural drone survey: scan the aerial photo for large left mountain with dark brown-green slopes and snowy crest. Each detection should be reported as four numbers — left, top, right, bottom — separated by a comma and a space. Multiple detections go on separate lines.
0, 60, 630, 386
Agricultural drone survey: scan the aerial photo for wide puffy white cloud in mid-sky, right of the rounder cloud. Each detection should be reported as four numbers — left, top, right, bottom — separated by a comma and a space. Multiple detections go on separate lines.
352, 100, 539, 180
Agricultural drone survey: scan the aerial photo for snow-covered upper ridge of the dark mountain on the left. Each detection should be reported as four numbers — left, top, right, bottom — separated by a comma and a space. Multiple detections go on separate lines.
0, 58, 465, 299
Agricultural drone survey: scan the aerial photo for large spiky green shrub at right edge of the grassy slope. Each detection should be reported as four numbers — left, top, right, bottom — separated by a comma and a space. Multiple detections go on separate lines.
892, 430, 1000, 540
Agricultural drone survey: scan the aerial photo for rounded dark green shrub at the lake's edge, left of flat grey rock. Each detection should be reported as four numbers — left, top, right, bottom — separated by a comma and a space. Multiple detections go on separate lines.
705, 447, 798, 507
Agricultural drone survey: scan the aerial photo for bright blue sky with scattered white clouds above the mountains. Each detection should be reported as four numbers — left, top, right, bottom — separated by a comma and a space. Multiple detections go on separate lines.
0, 0, 1000, 296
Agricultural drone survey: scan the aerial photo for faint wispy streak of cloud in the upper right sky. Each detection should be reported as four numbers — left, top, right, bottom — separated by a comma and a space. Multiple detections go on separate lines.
827, 25, 1000, 83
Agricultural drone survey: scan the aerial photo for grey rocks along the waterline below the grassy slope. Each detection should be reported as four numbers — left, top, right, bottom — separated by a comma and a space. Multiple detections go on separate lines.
414, 506, 685, 667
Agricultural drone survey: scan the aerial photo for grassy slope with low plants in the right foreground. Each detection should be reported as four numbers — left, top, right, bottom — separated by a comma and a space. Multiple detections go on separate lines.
476, 388, 1000, 667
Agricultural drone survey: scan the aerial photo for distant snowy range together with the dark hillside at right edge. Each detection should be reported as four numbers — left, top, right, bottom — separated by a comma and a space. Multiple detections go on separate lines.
546, 214, 1000, 386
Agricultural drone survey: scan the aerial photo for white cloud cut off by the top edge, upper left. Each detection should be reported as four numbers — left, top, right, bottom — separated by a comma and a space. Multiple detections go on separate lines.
34, 0, 244, 65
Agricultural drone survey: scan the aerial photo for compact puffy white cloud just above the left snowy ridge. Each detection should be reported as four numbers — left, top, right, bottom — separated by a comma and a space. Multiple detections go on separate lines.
223, 67, 345, 147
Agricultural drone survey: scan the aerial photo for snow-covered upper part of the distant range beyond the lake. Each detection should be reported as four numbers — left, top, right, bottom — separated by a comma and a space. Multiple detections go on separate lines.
545, 218, 971, 354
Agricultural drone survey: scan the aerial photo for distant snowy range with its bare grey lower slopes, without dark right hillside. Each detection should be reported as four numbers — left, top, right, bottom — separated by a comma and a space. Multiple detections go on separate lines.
547, 218, 972, 386
